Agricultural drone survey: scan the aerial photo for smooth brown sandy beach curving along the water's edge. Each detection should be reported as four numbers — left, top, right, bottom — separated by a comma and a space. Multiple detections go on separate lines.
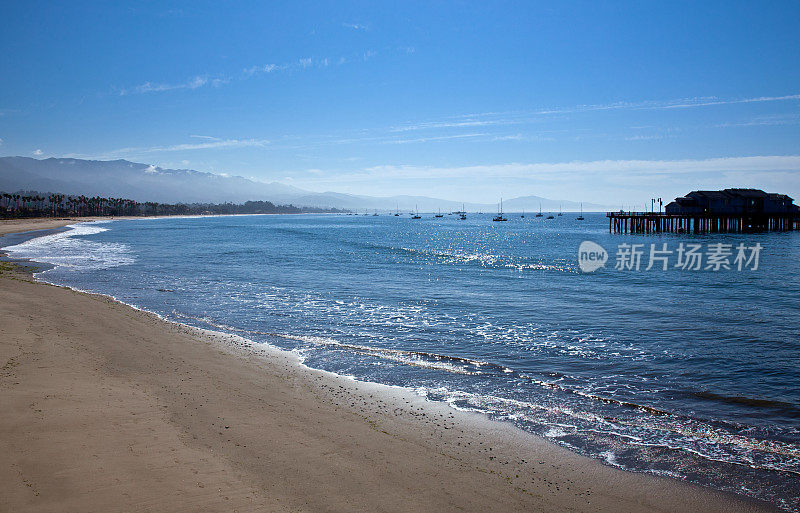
0, 220, 772, 512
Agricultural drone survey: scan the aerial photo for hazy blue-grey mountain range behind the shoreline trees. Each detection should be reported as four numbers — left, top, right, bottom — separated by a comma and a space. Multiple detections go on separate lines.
0, 157, 612, 212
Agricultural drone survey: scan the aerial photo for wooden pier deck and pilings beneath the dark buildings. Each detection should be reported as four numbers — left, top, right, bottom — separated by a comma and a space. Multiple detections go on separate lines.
606, 212, 800, 233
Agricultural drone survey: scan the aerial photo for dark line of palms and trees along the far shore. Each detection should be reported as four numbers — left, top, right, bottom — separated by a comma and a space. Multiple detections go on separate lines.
0, 191, 349, 219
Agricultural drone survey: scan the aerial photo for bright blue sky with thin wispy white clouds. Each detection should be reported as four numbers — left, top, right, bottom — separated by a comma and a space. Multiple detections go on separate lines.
0, 1, 800, 205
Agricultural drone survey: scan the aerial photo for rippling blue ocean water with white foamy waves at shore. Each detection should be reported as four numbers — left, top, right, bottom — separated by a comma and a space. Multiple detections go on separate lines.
4, 213, 800, 511
